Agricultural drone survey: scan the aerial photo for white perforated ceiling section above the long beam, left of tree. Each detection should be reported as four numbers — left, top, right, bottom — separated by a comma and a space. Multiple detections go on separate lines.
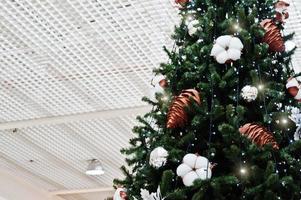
0, 0, 176, 122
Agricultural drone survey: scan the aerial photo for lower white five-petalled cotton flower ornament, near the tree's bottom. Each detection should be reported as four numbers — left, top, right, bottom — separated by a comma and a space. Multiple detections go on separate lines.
177, 153, 212, 186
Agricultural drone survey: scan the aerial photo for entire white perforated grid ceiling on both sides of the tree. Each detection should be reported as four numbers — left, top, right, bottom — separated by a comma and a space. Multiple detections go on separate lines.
0, 0, 301, 200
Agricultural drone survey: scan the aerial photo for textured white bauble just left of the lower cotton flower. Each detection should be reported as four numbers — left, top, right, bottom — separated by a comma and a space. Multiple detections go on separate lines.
149, 147, 168, 168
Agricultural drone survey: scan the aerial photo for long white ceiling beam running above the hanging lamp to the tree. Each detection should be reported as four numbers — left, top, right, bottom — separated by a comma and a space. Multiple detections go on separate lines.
0, 106, 151, 131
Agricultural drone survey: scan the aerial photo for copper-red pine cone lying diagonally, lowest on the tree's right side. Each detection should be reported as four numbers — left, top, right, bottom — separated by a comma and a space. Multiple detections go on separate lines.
239, 123, 279, 149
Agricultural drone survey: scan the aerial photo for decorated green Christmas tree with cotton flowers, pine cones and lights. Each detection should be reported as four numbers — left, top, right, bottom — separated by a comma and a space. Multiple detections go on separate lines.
115, 0, 301, 200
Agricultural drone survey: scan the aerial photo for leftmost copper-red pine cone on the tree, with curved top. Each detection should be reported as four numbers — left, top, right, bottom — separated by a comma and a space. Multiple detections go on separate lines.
167, 89, 201, 128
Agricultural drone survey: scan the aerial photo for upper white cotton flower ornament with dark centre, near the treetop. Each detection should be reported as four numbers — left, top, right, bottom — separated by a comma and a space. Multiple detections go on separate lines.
210, 35, 244, 64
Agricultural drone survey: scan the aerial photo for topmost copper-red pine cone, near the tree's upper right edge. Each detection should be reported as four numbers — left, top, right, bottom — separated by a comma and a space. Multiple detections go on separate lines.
260, 19, 285, 52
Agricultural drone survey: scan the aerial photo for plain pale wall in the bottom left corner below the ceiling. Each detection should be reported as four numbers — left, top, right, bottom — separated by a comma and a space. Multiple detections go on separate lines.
0, 171, 62, 200
